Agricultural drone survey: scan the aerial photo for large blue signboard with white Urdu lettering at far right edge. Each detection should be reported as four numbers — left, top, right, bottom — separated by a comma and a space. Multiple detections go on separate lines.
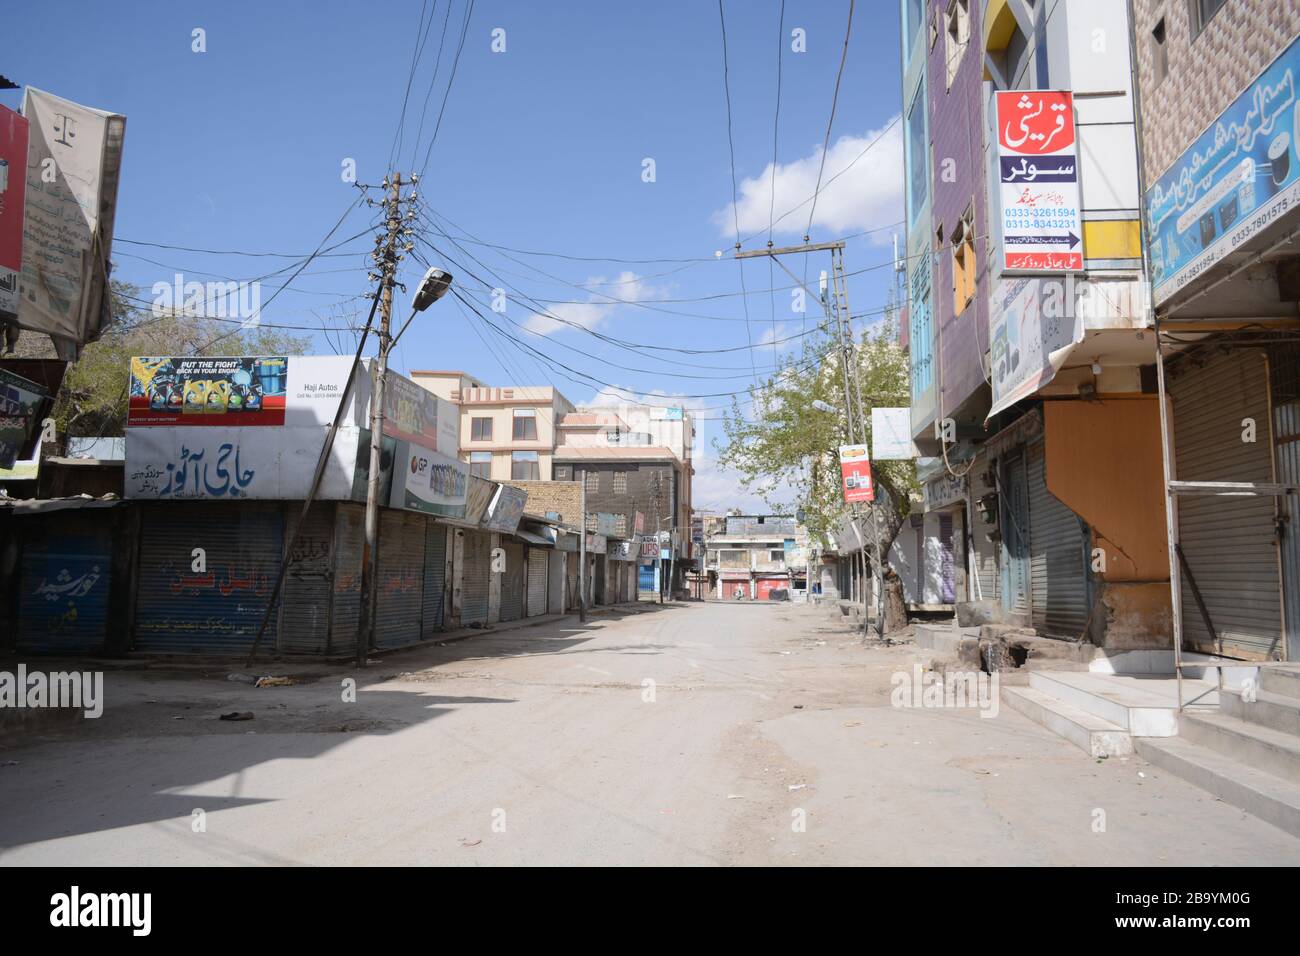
1147, 33, 1300, 306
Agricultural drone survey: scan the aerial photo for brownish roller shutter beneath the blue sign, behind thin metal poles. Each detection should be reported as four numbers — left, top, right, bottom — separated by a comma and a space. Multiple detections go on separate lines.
1169, 351, 1282, 658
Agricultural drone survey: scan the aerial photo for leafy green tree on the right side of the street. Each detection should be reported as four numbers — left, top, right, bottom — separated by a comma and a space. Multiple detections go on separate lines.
718, 316, 918, 632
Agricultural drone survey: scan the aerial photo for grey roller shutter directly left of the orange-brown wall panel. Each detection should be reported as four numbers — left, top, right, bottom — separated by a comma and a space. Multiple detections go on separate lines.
1027, 441, 1088, 639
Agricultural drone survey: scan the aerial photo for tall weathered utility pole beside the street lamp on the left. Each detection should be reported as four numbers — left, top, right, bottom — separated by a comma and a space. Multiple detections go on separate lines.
356, 173, 415, 667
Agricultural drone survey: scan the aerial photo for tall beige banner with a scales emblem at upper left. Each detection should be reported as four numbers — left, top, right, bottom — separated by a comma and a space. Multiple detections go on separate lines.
10, 86, 126, 358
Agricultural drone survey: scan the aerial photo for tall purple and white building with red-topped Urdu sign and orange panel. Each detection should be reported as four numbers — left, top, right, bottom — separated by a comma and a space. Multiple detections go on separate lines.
902, 0, 1169, 644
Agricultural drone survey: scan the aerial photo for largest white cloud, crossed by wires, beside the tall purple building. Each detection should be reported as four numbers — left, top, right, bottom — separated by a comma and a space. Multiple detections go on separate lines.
712, 122, 904, 243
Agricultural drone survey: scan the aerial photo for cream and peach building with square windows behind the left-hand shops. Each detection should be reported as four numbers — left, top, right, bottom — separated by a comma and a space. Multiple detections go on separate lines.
411, 371, 573, 481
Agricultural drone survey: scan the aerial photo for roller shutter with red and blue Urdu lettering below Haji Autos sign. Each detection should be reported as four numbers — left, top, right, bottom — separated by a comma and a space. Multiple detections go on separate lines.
135, 502, 283, 654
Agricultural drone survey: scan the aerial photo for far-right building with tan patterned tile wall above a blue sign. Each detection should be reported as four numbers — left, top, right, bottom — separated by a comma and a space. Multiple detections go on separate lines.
1134, 0, 1300, 665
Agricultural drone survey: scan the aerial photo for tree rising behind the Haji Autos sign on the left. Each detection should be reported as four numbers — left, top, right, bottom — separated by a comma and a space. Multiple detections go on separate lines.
53, 280, 311, 438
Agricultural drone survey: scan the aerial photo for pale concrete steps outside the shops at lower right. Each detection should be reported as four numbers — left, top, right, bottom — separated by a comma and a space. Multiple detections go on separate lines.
1002, 666, 1300, 836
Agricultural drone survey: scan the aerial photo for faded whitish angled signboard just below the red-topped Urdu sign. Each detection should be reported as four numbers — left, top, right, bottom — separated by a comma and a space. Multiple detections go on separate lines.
988, 276, 1083, 418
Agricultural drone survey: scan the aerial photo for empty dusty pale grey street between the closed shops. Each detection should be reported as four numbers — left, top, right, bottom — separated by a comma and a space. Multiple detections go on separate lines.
0, 604, 1300, 865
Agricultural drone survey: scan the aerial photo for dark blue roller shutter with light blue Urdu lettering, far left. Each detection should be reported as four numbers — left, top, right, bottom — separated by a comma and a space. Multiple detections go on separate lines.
17, 528, 112, 654
